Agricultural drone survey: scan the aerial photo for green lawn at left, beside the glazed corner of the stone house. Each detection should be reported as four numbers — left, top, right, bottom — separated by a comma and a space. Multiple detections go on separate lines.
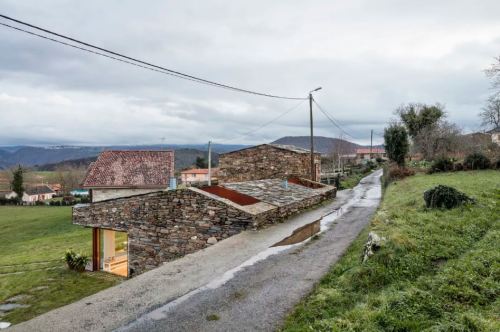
0, 206, 121, 323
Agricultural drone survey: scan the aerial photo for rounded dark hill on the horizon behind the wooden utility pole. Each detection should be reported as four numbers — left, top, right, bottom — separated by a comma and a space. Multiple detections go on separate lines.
273, 136, 365, 154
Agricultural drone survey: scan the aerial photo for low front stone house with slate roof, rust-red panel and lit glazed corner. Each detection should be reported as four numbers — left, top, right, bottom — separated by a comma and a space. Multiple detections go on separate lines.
73, 178, 336, 276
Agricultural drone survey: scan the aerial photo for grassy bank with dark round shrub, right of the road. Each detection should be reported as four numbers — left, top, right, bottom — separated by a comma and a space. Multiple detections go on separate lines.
283, 171, 500, 331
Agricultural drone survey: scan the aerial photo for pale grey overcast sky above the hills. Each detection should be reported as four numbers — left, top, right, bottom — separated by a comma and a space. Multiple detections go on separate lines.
0, 0, 500, 145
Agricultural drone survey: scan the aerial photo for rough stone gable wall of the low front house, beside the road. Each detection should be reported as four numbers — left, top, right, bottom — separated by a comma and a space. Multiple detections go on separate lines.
73, 189, 254, 275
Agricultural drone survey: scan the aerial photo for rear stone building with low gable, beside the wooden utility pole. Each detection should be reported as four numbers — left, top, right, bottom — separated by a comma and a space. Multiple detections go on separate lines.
218, 144, 321, 183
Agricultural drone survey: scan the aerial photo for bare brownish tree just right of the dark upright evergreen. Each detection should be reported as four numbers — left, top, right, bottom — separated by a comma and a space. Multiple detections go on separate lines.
414, 121, 461, 160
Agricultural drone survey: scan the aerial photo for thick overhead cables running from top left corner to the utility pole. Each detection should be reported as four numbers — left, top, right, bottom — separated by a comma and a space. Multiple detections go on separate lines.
0, 14, 307, 100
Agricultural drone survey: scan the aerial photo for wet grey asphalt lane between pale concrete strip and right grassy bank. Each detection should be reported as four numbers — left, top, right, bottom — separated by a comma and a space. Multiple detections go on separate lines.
119, 171, 381, 331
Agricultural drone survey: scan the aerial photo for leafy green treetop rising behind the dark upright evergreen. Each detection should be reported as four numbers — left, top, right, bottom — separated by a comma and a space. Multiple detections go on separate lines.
396, 103, 445, 139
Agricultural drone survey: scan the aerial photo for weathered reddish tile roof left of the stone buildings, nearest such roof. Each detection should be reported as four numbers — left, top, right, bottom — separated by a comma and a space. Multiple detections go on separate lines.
82, 151, 174, 188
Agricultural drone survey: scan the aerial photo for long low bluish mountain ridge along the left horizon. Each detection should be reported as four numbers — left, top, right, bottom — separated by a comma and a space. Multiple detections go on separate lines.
0, 144, 243, 169
